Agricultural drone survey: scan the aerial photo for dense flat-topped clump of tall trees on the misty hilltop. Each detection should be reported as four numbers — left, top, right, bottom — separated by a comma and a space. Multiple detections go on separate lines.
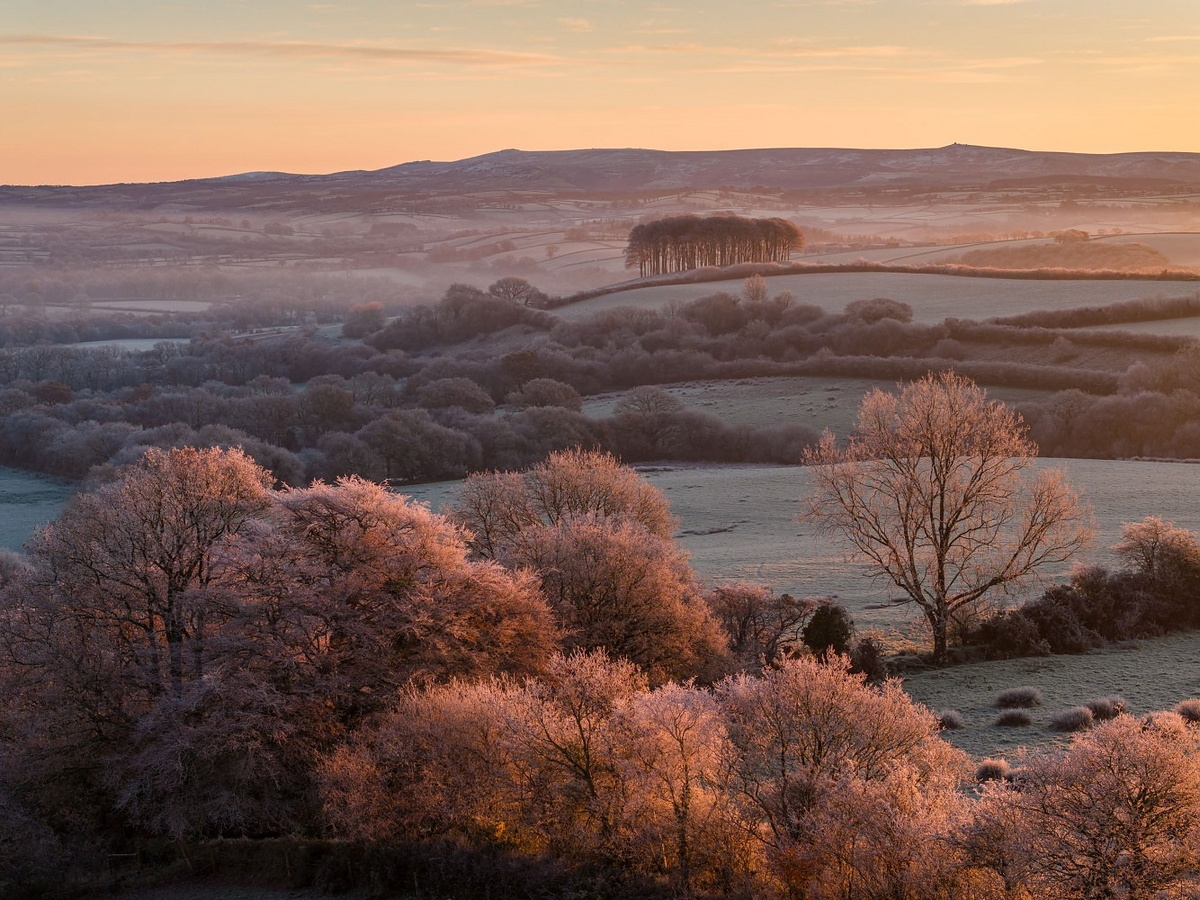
625, 215, 804, 277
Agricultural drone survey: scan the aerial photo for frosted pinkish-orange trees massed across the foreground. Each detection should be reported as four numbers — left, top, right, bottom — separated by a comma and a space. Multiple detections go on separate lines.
0, 448, 1200, 898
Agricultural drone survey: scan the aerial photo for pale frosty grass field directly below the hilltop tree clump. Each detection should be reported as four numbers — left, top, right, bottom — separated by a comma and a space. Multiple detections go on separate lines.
554, 272, 1196, 323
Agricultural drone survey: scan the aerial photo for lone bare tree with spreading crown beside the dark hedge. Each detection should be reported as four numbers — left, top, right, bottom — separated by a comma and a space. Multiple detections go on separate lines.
804, 372, 1091, 662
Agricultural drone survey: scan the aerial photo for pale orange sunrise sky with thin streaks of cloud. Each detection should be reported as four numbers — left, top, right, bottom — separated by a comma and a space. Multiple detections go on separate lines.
0, 0, 1200, 185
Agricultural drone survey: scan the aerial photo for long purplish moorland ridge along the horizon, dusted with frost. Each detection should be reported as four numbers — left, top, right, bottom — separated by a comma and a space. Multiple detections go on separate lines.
0, 144, 1200, 209
